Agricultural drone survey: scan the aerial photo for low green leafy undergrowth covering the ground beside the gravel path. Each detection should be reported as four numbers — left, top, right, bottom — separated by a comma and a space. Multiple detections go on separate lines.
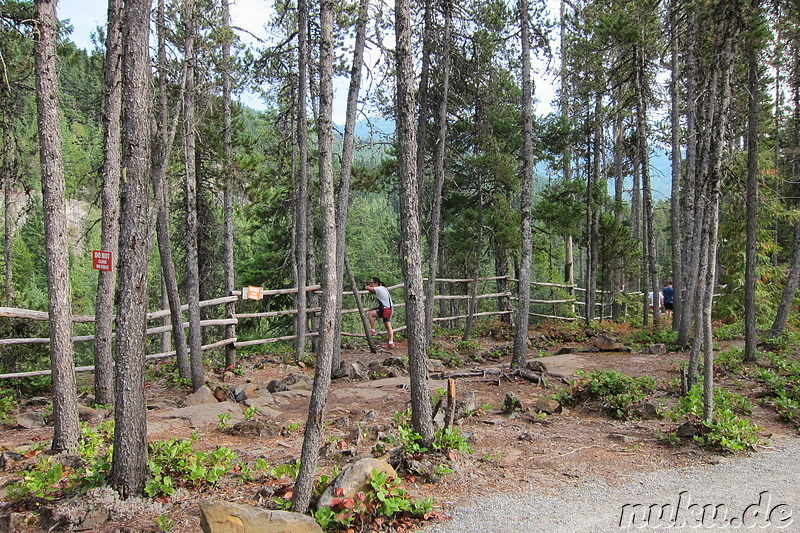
0, 323, 800, 532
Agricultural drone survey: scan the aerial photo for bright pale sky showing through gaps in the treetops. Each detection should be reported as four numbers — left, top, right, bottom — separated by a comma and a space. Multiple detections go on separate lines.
56, 0, 555, 125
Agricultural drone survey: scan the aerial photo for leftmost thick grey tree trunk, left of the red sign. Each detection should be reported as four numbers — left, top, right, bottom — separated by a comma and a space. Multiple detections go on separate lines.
34, 0, 80, 452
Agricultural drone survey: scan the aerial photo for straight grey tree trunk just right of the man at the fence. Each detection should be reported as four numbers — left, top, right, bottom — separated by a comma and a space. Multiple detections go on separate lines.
395, 0, 433, 441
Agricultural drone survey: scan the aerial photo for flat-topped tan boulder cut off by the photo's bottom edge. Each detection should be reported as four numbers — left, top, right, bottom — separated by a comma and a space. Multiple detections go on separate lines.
200, 502, 322, 533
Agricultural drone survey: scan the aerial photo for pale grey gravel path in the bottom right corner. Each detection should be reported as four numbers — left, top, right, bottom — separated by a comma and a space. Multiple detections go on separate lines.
425, 439, 800, 533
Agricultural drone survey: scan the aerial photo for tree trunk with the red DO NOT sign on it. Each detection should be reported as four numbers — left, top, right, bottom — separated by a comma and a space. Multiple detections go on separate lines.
94, 0, 122, 404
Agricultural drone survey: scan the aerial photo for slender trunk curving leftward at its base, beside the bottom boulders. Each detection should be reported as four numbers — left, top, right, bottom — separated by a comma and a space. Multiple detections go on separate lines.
292, 0, 341, 513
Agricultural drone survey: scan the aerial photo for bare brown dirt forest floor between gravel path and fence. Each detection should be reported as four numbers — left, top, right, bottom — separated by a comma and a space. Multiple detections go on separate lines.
0, 320, 797, 533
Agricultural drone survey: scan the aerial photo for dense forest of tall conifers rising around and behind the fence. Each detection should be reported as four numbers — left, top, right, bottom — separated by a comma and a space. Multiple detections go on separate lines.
0, 0, 800, 510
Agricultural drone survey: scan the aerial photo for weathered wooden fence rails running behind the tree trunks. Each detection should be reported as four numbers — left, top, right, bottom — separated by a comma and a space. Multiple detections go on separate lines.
0, 276, 604, 379
